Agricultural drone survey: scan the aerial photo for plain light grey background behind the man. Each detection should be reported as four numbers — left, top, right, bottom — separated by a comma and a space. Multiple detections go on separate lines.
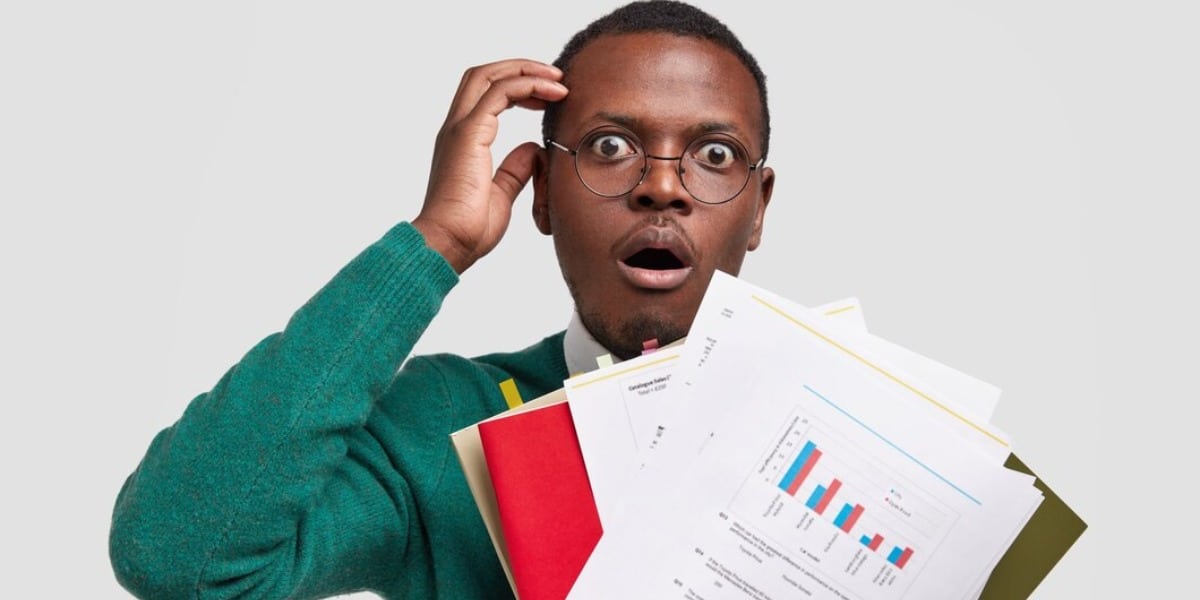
0, 0, 1200, 599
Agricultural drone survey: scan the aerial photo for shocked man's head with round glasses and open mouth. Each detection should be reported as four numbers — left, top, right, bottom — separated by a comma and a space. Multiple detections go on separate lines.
533, 1, 774, 358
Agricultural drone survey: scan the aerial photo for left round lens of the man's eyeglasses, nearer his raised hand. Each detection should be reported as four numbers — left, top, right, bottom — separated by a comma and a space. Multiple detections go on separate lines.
575, 130, 646, 197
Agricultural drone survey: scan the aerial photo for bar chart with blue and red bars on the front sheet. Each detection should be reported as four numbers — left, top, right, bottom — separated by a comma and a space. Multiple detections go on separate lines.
730, 412, 956, 596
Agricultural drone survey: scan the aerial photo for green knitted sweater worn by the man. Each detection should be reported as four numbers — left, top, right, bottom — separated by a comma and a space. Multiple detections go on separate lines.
109, 223, 566, 599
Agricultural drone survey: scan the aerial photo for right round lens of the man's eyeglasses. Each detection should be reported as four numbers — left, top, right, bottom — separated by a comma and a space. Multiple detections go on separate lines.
680, 133, 750, 204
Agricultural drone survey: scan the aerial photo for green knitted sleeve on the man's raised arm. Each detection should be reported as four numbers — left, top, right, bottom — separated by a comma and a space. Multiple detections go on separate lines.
109, 223, 457, 599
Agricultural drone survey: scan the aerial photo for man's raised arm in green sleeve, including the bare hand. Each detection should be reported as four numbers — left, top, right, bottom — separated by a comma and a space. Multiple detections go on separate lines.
110, 60, 566, 599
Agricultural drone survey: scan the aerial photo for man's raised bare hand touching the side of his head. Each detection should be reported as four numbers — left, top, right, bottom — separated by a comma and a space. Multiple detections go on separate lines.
413, 59, 566, 274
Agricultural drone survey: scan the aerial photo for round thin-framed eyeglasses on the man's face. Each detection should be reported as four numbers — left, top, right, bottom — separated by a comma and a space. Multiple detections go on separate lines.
546, 125, 766, 204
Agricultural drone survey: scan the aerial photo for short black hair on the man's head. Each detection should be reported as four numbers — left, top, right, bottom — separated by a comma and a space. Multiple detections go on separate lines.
541, 0, 770, 157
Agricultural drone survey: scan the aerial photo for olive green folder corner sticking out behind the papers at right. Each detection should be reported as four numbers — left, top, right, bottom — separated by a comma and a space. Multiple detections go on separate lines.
979, 454, 1087, 600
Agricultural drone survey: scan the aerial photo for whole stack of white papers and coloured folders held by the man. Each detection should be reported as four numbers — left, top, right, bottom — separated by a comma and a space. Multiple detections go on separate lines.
452, 272, 1086, 600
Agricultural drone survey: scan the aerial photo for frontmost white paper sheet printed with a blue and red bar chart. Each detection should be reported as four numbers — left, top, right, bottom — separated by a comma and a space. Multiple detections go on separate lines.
570, 274, 1040, 599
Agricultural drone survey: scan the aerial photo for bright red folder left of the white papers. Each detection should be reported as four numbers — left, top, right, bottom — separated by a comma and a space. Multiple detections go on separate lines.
479, 402, 601, 600
